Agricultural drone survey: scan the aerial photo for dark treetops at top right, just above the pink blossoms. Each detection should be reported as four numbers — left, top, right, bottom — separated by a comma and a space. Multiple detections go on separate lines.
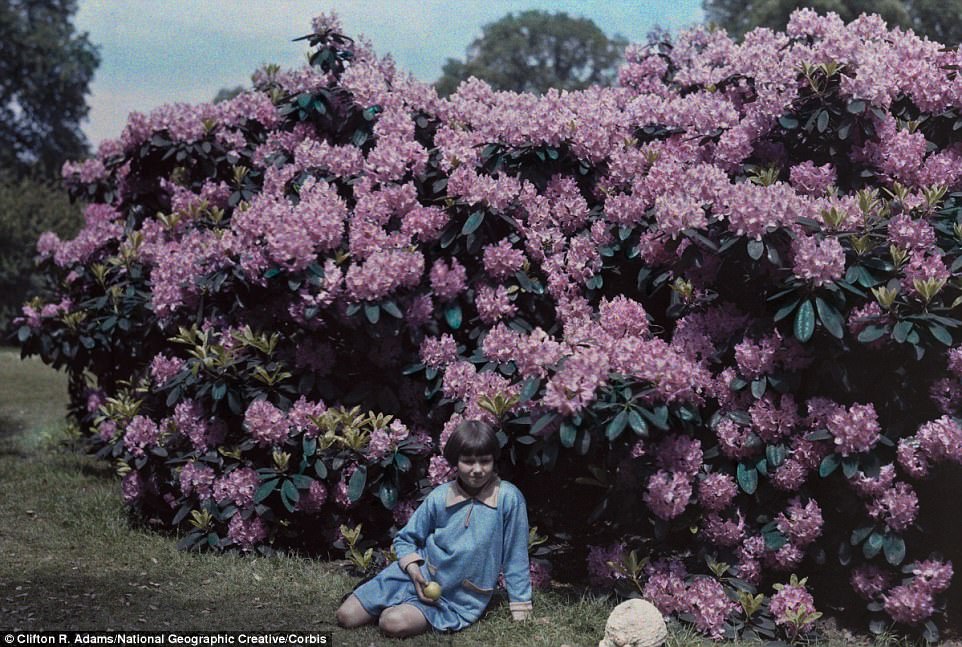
702, 0, 962, 46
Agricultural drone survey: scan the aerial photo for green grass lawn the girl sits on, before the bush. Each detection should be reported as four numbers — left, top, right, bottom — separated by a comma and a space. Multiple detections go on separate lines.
0, 348, 957, 647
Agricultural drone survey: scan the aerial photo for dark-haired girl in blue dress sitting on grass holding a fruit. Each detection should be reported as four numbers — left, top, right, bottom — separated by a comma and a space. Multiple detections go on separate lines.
337, 420, 531, 638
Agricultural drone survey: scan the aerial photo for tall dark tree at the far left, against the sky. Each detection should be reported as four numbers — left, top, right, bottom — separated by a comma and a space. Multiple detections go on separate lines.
0, 0, 100, 177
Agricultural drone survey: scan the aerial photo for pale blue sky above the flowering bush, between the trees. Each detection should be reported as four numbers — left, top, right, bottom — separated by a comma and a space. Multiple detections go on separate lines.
74, 0, 703, 146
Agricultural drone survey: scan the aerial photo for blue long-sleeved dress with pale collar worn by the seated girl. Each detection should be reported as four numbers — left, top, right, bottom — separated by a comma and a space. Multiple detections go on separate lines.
354, 477, 531, 631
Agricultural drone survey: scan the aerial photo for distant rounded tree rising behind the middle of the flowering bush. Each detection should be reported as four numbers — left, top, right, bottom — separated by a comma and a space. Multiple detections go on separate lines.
435, 11, 627, 95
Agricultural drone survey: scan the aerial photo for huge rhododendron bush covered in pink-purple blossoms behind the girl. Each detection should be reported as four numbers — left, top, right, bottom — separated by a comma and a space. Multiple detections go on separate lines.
18, 10, 962, 640
